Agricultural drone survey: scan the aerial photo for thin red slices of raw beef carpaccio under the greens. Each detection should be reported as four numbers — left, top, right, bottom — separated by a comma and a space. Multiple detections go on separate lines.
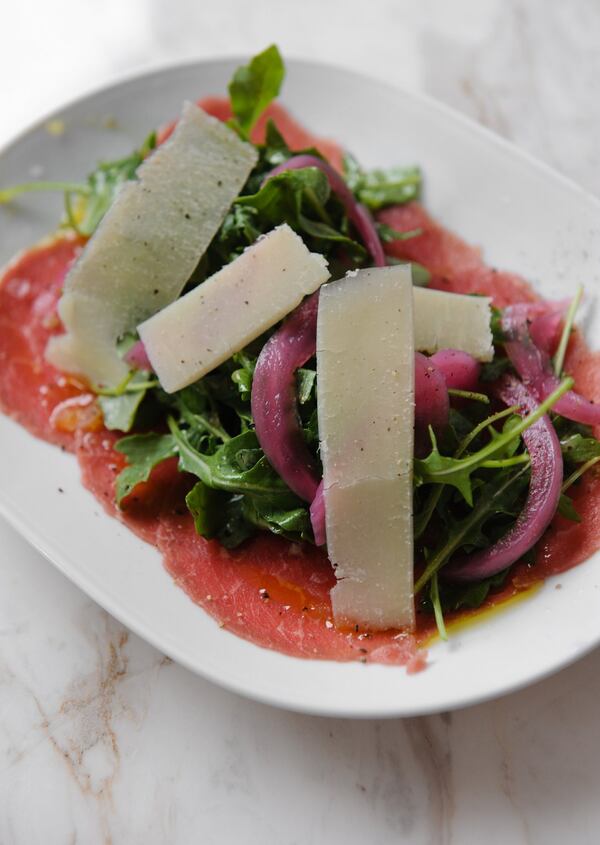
0, 79, 600, 671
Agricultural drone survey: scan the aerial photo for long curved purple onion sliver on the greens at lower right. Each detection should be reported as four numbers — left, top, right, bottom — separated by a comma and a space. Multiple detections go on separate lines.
442, 376, 563, 582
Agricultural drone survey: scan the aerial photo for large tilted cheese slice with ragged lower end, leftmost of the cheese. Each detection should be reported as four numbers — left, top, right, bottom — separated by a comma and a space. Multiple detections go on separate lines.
47, 103, 257, 385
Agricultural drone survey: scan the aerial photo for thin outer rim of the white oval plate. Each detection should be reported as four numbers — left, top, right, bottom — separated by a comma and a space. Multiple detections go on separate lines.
0, 56, 600, 718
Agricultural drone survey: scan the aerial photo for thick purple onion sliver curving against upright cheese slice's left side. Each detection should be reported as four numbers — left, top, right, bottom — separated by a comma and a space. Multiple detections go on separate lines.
252, 292, 320, 502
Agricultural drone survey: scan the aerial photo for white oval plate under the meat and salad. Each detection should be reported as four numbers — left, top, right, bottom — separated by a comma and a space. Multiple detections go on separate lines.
0, 60, 600, 717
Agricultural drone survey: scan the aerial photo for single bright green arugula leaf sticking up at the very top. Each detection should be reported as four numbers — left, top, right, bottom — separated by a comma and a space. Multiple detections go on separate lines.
229, 44, 285, 138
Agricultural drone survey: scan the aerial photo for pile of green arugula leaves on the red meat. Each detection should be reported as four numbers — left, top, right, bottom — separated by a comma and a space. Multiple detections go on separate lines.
5, 46, 600, 634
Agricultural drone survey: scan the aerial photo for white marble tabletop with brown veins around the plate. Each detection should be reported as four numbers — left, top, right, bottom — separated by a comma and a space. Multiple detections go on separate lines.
0, 0, 600, 845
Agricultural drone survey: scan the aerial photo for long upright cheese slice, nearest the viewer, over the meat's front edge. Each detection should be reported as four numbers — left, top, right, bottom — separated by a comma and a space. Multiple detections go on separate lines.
317, 265, 414, 630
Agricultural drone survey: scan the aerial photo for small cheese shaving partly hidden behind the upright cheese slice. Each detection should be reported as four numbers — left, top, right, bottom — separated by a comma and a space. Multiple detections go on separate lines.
413, 288, 494, 361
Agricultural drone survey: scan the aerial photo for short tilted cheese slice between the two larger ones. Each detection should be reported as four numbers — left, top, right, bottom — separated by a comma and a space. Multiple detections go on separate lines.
138, 223, 329, 393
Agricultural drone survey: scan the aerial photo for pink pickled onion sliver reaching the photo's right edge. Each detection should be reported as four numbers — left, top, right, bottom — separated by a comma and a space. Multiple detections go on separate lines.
502, 306, 600, 426
